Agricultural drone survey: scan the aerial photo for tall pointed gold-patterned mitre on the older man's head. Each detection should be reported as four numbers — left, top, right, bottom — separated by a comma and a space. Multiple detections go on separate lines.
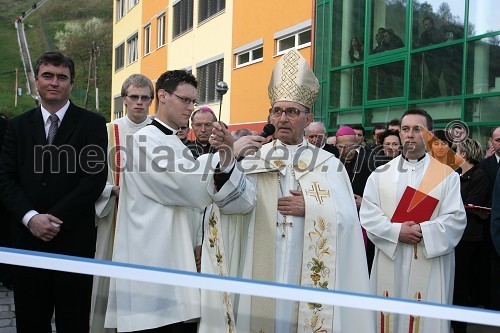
268, 49, 319, 108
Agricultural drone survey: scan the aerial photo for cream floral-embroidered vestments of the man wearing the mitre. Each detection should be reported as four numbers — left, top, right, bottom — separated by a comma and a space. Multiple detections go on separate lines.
199, 141, 375, 333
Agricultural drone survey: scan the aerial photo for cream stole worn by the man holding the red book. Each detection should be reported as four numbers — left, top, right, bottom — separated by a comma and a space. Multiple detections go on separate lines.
376, 157, 451, 333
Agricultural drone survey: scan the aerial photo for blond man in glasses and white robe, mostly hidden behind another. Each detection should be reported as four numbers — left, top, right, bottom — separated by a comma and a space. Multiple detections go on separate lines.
90, 74, 154, 333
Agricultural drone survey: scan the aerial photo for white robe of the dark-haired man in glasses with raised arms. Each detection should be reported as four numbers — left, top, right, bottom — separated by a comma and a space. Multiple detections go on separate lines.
105, 119, 255, 332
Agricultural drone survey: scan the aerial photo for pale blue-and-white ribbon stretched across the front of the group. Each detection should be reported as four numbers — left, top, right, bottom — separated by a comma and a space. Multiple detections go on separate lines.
0, 247, 500, 327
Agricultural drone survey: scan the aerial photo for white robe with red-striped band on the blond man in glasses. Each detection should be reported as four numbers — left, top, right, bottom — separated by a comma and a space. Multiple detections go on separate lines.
90, 116, 151, 333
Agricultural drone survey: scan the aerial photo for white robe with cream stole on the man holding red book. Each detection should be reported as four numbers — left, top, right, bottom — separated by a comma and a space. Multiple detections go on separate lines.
360, 154, 467, 333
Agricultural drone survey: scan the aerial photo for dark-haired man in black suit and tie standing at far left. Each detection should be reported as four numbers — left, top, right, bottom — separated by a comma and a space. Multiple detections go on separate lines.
0, 52, 107, 333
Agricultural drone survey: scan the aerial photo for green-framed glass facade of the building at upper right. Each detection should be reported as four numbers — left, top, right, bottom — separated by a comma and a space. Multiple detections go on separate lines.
314, 0, 500, 144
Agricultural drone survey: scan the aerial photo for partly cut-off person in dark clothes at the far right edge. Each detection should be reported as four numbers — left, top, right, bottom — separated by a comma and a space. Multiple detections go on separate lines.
479, 127, 500, 310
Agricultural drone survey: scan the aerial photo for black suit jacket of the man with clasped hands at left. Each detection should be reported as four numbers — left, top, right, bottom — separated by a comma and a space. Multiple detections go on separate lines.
0, 103, 107, 257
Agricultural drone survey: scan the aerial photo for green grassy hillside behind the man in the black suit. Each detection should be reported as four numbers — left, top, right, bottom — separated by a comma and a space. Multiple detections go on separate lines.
0, 0, 113, 120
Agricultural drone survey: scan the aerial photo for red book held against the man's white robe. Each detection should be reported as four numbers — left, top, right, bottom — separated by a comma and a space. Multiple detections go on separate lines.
391, 186, 439, 223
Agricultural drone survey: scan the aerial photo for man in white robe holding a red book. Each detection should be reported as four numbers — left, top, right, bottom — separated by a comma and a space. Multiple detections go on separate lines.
359, 109, 467, 333
